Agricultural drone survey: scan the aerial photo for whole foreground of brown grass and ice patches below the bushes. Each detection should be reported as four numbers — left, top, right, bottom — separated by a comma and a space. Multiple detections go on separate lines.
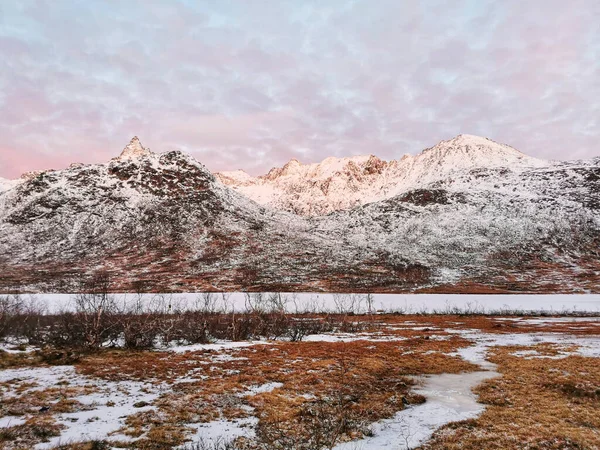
0, 315, 600, 450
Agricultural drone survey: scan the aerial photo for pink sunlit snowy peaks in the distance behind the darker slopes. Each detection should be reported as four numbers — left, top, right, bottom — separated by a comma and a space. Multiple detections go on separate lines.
216, 134, 547, 216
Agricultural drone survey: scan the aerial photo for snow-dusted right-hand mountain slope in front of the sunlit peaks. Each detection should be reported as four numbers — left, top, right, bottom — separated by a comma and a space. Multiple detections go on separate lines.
311, 156, 600, 292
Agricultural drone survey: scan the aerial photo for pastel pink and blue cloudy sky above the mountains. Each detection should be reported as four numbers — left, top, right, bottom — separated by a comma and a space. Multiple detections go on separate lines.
0, 0, 600, 178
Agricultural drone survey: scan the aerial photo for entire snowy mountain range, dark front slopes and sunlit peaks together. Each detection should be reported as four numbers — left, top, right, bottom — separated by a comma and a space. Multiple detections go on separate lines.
0, 135, 600, 293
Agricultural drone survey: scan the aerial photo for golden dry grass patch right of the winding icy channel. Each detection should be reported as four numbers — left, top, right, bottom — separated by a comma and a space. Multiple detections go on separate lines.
422, 345, 600, 450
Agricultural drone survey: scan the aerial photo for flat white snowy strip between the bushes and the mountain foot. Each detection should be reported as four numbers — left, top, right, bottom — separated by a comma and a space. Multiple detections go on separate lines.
18, 292, 600, 314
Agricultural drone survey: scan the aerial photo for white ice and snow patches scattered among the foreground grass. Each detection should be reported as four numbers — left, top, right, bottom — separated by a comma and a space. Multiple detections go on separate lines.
0, 318, 600, 450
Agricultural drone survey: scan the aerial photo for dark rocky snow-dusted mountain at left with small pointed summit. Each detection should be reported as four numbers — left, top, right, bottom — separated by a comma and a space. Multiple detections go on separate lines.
0, 138, 380, 292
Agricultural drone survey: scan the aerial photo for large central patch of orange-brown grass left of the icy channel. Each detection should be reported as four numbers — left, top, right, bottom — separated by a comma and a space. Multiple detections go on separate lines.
77, 336, 477, 449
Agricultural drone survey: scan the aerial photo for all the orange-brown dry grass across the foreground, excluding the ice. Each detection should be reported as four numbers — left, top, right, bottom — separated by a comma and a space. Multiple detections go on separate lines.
0, 315, 600, 450
